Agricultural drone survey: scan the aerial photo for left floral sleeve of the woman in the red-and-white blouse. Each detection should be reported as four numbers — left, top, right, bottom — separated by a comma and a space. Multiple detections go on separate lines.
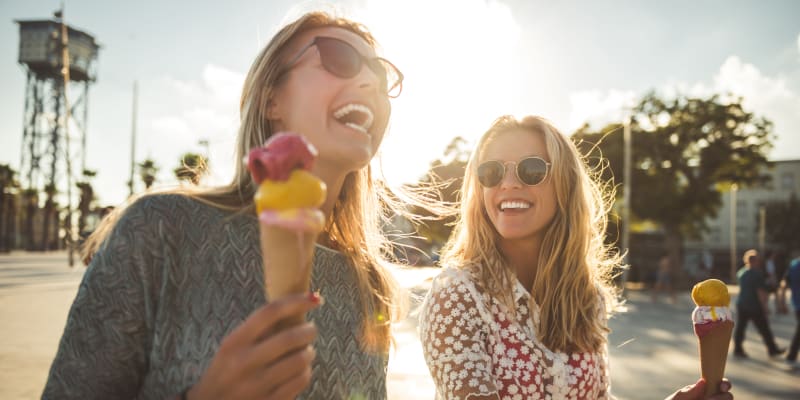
420, 271, 497, 400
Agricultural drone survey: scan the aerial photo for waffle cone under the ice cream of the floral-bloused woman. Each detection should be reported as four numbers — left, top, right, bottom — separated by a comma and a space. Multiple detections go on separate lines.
698, 321, 733, 398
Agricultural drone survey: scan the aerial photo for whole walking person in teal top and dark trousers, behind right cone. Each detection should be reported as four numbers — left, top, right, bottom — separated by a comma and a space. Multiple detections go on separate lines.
733, 249, 786, 358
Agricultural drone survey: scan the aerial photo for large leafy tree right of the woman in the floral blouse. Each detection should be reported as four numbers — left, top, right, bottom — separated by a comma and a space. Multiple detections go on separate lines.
574, 93, 772, 276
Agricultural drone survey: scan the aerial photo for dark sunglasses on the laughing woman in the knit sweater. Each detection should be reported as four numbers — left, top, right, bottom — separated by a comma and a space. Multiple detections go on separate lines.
281, 36, 403, 98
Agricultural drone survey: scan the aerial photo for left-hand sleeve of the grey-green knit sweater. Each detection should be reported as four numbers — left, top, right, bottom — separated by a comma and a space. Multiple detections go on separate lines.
42, 198, 162, 399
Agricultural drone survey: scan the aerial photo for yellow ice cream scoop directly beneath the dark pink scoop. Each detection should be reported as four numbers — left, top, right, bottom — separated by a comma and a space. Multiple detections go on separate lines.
253, 169, 327, 214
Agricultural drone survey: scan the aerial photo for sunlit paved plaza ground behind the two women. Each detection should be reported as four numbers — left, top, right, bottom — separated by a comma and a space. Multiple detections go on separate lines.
0, 252, 800, 400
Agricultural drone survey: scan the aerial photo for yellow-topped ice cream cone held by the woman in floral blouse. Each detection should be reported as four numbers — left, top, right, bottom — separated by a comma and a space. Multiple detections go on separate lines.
692, 279, 733, 398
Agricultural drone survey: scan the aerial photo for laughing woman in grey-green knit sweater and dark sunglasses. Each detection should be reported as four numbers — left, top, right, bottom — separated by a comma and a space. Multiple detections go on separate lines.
43, 13, 403, 400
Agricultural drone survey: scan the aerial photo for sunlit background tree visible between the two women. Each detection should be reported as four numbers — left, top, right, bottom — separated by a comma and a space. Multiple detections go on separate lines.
410, 136, 470, 244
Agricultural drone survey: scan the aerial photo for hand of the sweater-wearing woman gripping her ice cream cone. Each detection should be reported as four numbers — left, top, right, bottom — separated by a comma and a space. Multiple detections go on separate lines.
186, 294, 321, 400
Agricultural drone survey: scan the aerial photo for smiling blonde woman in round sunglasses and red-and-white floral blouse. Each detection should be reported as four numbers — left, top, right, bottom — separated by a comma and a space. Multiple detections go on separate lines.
420, 116, 731, 399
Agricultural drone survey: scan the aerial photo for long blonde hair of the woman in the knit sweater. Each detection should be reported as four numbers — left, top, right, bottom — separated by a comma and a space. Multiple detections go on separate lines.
83, 12, 401, 352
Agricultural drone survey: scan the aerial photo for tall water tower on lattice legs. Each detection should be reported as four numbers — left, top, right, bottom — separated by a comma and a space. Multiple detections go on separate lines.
15, 11, 100, 250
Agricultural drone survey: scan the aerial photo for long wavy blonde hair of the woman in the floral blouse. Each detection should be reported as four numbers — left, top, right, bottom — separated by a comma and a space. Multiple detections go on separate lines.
442, 116, 620, 352
